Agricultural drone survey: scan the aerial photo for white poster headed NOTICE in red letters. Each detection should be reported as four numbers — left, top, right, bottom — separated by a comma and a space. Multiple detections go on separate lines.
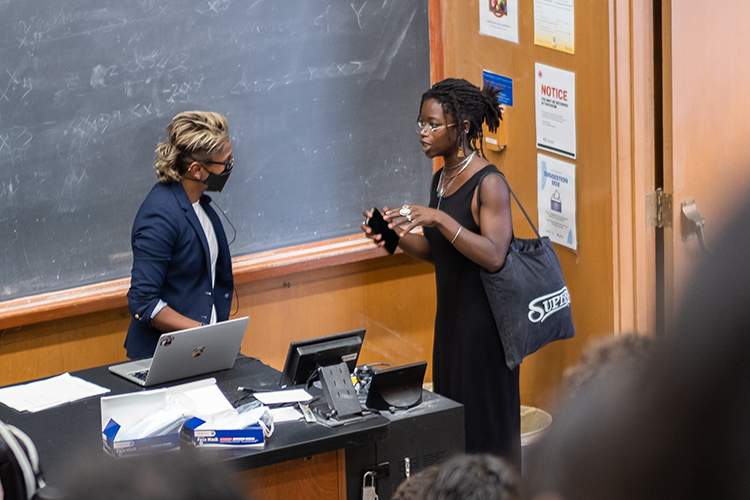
534, 63, 576, 158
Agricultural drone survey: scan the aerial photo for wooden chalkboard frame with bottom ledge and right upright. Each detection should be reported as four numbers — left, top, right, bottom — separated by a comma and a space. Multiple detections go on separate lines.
0, 0, 444, 330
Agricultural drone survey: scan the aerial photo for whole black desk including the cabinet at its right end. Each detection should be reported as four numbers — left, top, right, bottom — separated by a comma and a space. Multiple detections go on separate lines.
0, 356, 464, 500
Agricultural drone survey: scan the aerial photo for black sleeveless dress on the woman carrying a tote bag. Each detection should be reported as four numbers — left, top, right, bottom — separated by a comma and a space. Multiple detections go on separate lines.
424, 165, 521, 463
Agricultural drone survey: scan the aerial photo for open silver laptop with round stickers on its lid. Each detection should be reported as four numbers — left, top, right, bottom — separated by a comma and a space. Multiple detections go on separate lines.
109, 316, 249, 387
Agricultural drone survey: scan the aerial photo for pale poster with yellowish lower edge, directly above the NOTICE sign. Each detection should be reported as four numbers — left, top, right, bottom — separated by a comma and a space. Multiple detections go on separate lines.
534, 0, 575, 54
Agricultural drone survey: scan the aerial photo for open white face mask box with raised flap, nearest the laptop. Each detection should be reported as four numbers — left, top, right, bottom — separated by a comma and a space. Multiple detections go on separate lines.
101, 378, 232, 457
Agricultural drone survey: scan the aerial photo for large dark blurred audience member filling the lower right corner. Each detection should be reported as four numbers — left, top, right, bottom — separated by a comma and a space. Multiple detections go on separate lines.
528, 199, 750, 500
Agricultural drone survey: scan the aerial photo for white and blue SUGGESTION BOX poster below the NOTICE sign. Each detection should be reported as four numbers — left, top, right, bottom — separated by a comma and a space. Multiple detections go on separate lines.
537, 153, 578, 251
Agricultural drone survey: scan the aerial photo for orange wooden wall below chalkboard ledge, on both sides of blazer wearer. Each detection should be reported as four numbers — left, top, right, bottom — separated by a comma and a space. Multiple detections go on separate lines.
0, 255, 435, 386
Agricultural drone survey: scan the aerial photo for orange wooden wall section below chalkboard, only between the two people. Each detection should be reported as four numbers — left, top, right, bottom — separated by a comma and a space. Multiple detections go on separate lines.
238, 257, 435, 376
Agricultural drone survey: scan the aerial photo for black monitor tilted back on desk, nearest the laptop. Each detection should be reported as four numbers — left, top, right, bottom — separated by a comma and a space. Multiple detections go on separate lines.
279, 329, 365, 388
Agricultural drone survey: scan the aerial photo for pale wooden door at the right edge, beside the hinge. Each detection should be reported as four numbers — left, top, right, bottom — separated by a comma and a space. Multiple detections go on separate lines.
657, 0, 750, 328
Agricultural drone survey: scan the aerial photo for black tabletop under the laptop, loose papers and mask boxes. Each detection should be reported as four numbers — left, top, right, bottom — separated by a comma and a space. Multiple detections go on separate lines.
0, 356, 389, 484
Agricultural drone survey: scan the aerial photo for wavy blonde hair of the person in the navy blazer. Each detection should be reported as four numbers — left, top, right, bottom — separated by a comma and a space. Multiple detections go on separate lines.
154, 111, 229, 182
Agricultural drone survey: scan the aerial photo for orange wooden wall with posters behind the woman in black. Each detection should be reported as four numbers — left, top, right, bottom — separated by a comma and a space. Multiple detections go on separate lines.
441, 0, 614, 406
